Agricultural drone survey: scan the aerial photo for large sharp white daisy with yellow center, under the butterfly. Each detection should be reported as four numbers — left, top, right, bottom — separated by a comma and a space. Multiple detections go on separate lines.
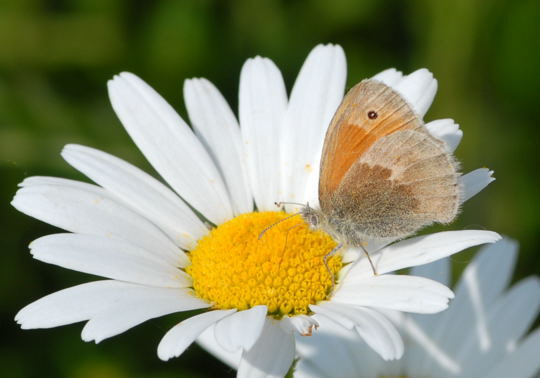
13, 45, 499, 377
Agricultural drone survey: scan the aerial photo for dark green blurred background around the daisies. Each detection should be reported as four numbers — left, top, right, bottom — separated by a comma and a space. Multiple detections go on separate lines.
0, 0, 540, 378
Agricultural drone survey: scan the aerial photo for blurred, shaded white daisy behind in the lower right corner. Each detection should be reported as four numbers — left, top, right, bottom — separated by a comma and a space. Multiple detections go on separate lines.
294, 239, 540, 378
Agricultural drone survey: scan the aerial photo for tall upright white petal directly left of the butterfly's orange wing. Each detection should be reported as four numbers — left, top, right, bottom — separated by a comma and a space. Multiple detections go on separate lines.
282, 45, 346, 210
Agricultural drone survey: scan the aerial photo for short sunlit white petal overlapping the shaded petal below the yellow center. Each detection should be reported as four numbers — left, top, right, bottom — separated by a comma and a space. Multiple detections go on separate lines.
214, 306, 268, 353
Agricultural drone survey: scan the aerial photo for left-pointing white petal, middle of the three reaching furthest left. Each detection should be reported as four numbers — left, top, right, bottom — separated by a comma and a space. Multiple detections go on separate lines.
30, 234, 191, 288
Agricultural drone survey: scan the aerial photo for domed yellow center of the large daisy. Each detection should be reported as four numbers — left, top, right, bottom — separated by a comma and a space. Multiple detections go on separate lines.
186, 212, 342, 318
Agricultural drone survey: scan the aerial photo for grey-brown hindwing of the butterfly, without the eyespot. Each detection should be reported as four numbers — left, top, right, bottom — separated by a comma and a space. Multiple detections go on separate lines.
329, 130, 459, 242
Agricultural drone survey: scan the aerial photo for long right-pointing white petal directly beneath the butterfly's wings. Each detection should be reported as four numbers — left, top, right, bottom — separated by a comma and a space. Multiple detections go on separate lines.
347, 230, 501, 279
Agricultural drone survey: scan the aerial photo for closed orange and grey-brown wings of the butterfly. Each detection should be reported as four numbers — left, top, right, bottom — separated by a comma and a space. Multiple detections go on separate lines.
320, 81, 459, 244
